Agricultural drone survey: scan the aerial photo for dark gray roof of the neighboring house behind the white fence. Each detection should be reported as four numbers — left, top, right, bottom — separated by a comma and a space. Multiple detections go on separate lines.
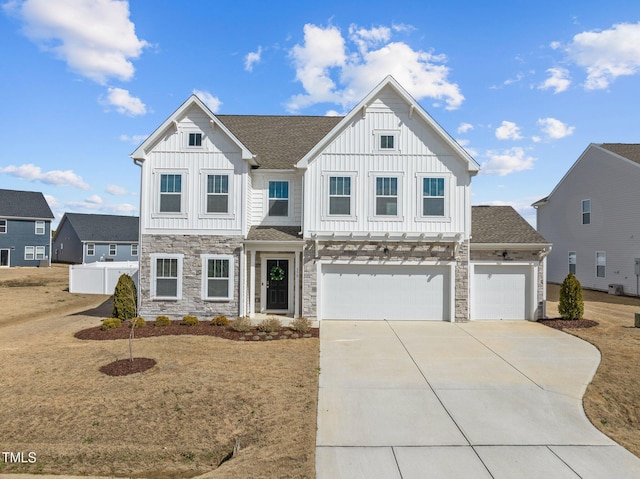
56, 213, 139, 243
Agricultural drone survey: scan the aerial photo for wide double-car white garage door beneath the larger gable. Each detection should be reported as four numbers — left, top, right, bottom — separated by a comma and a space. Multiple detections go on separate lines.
320, 264, 449, 321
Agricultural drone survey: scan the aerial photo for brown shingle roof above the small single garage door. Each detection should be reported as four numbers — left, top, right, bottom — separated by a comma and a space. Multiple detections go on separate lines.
471, 206, 548, 244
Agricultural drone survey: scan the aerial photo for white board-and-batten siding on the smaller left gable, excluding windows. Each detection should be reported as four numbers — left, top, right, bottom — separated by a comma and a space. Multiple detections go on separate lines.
140, 107, 249, 235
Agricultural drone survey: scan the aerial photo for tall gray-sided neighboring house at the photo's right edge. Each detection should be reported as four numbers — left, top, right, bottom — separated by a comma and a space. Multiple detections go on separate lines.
533, 143, 640, 295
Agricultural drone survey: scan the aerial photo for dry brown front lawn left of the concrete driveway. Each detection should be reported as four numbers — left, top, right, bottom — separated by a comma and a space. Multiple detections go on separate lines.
0, 267, 319, 478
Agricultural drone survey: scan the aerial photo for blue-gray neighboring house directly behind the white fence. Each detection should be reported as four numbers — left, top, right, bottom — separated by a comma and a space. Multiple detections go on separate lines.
53, 213, 139, 264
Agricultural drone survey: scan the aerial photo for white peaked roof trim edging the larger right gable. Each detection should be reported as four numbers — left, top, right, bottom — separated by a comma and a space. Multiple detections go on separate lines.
296, 75, 480, 173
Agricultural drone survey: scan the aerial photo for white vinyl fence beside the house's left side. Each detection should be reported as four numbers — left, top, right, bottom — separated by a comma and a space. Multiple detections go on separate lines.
69, 261, 138, 294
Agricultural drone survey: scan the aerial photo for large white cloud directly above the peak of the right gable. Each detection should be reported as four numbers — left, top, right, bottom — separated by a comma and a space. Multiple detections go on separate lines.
287, 24, 464, 112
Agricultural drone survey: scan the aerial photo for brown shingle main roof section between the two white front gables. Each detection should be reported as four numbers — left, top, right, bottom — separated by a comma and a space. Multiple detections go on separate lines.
216, 115, 342, 170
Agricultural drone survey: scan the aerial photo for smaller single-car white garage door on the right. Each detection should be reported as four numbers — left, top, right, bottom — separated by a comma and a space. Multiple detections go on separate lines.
471, 265, 531, 320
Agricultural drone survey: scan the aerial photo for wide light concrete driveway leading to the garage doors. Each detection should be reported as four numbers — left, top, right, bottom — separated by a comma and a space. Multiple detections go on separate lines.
316, 321, 640, 479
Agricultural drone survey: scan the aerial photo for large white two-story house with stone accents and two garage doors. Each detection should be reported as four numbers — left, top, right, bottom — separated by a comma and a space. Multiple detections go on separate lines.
131, 77, 549, 321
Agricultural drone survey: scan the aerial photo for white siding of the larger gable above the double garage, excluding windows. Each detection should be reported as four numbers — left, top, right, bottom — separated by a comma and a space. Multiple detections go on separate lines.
304, 88, 471, 236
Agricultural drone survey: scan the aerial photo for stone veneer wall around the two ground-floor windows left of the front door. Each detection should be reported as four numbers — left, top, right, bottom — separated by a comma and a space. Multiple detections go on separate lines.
138, 235, 242, 320
